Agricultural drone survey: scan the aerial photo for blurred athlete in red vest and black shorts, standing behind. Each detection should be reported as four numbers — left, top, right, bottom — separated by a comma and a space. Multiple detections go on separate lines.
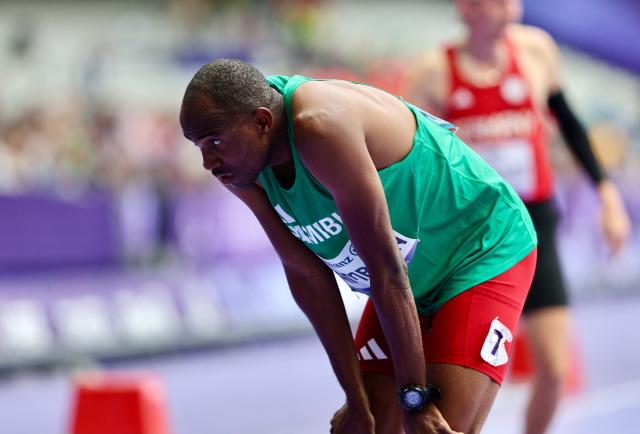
407, 0, 630, 434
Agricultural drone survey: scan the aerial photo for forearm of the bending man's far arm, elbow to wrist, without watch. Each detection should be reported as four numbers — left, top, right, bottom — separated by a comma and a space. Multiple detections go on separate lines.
285, 269, 368, 408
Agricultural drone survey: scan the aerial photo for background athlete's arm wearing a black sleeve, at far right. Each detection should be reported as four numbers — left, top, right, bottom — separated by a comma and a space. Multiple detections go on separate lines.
539, 31, 631, 253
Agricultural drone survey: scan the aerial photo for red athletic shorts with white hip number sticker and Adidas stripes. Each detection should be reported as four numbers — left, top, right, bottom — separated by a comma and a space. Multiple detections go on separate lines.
355, 249, 537, 384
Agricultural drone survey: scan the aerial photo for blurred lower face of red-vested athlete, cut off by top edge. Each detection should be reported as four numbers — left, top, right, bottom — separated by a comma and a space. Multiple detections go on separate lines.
456, 0, 522, 38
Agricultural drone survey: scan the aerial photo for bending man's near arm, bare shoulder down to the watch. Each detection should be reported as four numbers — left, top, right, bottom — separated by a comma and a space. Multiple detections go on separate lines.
295, 98, 426, 385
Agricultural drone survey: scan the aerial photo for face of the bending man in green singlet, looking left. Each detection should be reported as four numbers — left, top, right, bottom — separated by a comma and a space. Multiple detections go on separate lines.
181, 109, 269, 187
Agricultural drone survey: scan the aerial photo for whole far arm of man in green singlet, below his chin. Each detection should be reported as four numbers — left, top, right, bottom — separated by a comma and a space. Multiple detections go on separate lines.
227, 185, 373, 424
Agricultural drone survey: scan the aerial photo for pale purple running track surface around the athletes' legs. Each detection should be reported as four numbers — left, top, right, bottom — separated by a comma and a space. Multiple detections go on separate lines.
0, 295, 640, 434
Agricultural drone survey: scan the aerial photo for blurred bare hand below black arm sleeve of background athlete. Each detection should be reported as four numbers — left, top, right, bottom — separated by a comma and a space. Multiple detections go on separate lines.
598, 181, 631, 256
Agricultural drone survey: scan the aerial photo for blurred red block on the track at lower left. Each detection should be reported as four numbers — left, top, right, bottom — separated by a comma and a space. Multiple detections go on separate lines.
69, 372, 171, 434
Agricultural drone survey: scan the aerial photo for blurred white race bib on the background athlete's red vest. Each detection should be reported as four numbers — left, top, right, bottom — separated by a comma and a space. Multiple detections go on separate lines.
473, 139, 536, 199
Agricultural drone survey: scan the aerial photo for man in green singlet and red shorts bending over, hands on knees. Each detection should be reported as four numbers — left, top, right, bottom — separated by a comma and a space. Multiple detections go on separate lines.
180, 59, 537, 434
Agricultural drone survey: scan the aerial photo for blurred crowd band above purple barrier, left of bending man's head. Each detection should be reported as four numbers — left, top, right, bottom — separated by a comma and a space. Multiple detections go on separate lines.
0, 99, 199, 196
